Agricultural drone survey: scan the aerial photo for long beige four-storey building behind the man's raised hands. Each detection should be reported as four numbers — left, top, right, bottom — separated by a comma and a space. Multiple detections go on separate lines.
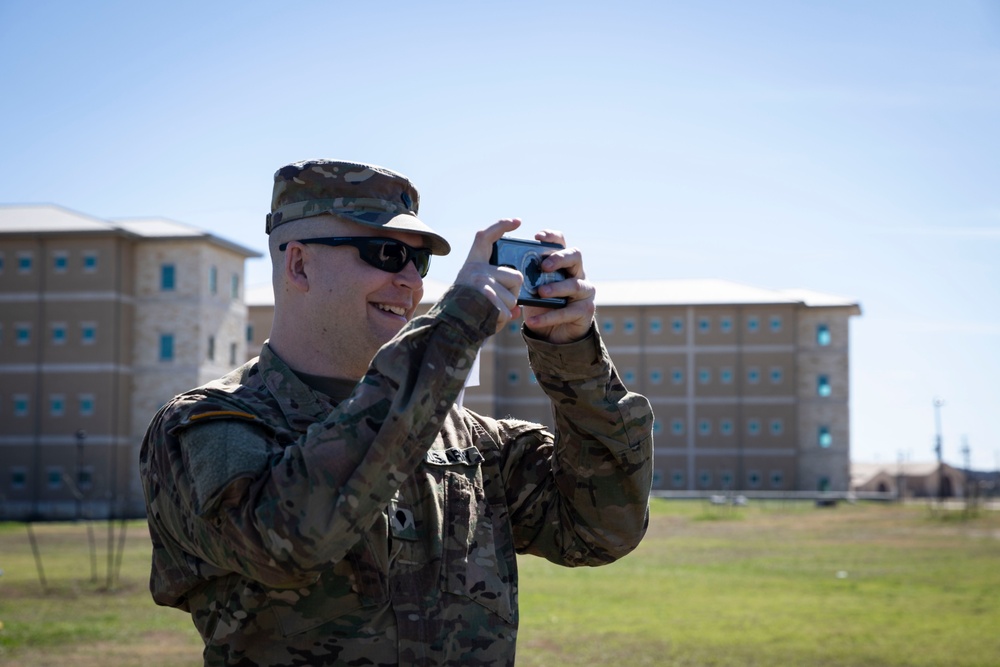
248, 280, 861, 492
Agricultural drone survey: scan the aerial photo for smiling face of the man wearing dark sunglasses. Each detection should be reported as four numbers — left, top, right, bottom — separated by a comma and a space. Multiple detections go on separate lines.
296, 220, 426, 378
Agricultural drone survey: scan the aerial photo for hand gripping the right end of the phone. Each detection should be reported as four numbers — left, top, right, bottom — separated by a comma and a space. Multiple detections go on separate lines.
522, 229, 596, 343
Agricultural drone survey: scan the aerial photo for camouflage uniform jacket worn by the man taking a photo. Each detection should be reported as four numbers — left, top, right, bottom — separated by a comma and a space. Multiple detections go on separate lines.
141, 287, 652, 666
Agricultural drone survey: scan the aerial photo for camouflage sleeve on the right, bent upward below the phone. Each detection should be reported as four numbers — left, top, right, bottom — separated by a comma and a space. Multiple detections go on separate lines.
498, 329, 653, 566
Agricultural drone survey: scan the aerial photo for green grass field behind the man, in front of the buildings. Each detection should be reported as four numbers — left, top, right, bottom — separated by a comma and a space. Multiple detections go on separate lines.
0, 501, 1000, 667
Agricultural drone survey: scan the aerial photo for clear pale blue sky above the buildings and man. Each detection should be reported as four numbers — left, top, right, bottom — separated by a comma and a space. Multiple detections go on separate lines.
0, 0, 1000, 469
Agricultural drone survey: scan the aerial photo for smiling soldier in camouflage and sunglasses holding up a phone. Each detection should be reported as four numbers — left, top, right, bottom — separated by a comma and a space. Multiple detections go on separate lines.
141, 160, 653, 667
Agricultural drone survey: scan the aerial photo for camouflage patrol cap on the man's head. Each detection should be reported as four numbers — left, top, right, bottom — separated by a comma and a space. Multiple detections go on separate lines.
266, 160, 451, 255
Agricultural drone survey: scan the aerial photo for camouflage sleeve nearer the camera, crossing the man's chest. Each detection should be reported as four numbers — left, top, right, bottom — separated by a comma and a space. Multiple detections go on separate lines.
143, 287, 497, 587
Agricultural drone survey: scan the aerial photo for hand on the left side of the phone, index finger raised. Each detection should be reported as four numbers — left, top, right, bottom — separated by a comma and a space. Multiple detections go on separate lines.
455, 218, 524, 331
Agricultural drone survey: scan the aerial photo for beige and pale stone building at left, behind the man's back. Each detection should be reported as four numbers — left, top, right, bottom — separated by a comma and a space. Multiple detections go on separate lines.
0, 206, 259, 519
